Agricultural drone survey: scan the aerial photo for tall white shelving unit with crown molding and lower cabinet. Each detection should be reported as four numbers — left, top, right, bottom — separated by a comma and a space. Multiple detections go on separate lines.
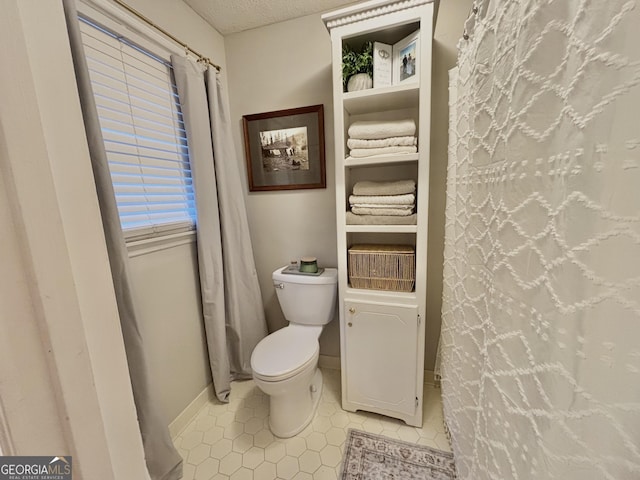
322, 0, 433, 426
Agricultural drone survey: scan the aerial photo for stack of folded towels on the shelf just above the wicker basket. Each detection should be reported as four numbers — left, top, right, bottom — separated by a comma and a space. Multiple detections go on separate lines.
347, 180, 416, 225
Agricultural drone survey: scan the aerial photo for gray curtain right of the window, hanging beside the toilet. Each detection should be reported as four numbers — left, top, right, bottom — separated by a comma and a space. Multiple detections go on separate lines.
171, 55, 267, 402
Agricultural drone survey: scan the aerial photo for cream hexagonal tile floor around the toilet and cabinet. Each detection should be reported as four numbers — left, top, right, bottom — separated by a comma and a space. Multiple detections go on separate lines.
174, 369, 451, 480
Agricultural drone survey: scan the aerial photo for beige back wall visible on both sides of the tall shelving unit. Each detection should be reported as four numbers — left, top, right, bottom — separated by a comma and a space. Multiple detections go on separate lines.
225, 0, 471, 370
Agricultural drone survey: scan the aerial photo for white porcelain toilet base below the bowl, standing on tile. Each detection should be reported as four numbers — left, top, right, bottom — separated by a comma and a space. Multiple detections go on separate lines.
269, 368, 322, 438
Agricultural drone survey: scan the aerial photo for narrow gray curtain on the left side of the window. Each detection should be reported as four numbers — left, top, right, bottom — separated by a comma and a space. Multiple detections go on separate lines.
63, 0, 182, 480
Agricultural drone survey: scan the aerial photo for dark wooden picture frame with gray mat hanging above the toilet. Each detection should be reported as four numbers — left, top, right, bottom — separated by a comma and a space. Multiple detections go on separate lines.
242, 105, 327, 192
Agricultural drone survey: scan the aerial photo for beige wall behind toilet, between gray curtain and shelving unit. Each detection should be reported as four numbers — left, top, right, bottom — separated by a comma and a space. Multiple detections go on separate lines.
225, 15, 340, 356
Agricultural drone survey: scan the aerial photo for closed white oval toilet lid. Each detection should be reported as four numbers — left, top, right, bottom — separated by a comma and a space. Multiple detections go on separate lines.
251, 327, 320, 379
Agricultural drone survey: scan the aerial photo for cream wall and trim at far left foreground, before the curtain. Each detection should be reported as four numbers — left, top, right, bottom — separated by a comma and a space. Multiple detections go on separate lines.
0, 0, 148, 479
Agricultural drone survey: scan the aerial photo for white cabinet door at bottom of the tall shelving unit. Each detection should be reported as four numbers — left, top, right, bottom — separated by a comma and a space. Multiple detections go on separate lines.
344, 300, 422, 415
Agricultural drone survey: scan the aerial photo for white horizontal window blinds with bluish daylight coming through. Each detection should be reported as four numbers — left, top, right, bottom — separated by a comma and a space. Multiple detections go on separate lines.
80, 17, 196, 240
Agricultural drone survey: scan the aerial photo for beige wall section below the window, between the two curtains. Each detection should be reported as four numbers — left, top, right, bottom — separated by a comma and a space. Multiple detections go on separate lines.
130, 242, 211, 424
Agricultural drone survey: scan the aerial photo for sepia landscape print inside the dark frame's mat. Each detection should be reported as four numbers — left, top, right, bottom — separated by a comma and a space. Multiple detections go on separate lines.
260, 127, 309, 172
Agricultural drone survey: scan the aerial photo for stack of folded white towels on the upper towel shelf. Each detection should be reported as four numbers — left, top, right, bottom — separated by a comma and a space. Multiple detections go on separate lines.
347, 119, 418, 158
